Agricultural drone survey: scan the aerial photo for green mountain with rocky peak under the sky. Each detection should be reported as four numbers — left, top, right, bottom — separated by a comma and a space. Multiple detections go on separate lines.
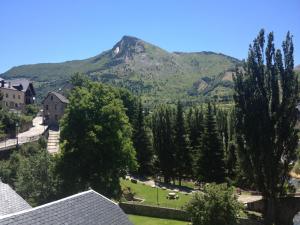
0, 36, 240, 104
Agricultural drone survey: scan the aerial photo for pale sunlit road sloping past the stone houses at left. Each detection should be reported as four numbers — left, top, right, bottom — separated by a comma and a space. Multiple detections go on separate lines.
0, 116, 47, 151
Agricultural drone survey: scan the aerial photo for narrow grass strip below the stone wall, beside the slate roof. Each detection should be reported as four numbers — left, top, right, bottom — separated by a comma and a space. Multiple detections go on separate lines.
128, 215, 189, 225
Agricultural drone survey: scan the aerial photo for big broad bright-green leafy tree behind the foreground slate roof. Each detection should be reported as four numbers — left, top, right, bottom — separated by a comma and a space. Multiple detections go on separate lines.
57, 83, 137, 197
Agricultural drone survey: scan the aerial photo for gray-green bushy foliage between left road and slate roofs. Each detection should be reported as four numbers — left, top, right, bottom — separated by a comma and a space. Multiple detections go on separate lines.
0, 141, 58, 206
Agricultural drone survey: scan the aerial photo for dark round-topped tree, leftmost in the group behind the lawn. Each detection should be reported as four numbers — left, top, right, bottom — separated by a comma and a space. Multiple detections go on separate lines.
152, 106, 175, 183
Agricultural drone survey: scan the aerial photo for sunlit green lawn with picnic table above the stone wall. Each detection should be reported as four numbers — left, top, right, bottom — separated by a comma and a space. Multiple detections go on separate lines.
121, 179, 192, 209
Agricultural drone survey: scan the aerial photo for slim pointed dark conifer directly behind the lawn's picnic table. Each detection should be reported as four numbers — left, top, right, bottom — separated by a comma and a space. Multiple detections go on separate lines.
174, 101, 192, 186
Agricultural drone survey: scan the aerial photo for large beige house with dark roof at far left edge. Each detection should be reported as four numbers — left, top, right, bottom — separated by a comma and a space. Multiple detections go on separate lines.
0, 78, 35, 110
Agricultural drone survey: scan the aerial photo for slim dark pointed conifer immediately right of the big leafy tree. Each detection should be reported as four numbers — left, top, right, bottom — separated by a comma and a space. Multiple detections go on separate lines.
133, 101, 153, 176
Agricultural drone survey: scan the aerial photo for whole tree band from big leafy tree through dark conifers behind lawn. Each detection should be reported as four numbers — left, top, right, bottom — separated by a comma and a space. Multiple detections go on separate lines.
57, 74, 239, 196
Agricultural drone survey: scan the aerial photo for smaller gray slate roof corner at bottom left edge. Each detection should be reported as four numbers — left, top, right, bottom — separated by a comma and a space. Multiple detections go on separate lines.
0, 181, 31, 217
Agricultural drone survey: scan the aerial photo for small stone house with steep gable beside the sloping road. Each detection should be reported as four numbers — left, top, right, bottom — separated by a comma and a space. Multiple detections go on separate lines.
43, 91, 69, 127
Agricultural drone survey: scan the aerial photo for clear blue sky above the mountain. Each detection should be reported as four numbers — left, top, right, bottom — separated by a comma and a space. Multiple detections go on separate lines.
0, 0, 300, 73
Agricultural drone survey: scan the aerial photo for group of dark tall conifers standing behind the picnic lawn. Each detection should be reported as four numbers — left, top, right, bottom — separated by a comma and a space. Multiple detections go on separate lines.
151, 102, 227, 184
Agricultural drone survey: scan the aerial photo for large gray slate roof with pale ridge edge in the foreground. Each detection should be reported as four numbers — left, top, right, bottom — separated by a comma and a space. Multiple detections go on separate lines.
0, 190, 132, 225
